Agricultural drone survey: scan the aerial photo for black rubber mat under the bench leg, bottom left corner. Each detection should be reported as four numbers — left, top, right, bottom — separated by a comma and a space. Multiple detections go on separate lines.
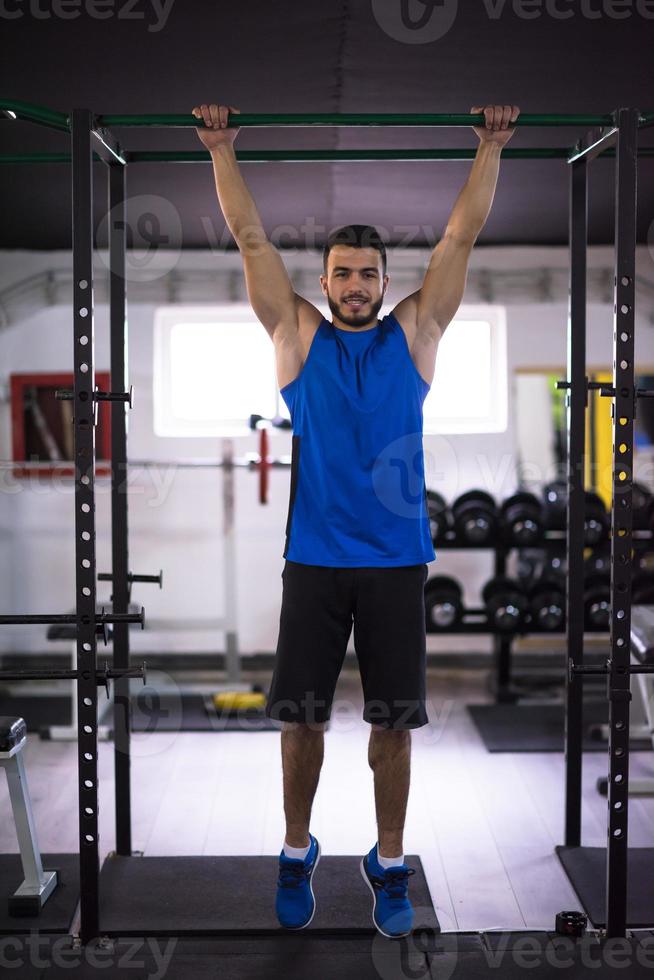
0, 853, 79, 936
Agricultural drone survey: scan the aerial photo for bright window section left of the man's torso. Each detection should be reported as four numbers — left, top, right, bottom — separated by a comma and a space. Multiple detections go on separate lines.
153, 303, 289, 437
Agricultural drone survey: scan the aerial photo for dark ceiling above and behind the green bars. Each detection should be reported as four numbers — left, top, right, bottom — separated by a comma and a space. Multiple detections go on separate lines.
0, 0, 654, 249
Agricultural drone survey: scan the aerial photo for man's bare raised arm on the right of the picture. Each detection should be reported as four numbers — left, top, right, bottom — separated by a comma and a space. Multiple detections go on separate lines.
393, 105, 520, 343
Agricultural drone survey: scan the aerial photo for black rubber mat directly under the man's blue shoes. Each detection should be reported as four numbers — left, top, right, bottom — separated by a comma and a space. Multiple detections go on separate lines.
100, 854, 440, 936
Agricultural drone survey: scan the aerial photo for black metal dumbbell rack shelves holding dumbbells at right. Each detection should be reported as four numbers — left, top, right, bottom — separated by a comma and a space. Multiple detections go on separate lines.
429, 530, 654, 703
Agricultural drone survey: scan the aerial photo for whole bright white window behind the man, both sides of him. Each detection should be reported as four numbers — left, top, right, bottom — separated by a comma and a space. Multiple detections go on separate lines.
154, 303, 507, 437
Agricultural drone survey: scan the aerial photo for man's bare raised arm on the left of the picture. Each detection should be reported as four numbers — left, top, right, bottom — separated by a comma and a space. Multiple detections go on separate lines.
193, 104, 309, 339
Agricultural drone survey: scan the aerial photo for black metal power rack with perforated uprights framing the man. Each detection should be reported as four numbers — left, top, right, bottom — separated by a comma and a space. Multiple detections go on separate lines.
0, 100, 654, 943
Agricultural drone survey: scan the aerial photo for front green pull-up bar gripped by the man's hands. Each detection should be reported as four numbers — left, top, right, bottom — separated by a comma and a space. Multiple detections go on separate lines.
97, 112, 614, 127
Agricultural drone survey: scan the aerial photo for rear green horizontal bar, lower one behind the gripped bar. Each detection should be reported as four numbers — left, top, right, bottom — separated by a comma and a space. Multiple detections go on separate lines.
0, 146, 654, 165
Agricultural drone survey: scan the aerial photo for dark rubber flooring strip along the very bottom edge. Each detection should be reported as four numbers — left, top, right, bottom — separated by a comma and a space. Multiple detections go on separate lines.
26, 930, 654, 980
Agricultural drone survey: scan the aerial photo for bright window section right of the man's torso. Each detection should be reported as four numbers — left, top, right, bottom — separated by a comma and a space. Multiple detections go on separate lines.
423, 306, 508, 435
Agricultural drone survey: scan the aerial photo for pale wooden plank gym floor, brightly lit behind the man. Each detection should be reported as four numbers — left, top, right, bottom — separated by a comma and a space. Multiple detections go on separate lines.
0, 669, 654, 931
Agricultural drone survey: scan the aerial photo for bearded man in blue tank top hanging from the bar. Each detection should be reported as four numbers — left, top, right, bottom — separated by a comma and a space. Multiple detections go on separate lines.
193, 104, 519, 938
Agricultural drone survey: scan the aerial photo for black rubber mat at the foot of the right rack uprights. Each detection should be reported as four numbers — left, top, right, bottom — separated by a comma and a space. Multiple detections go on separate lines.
556, 844, 654, 932
